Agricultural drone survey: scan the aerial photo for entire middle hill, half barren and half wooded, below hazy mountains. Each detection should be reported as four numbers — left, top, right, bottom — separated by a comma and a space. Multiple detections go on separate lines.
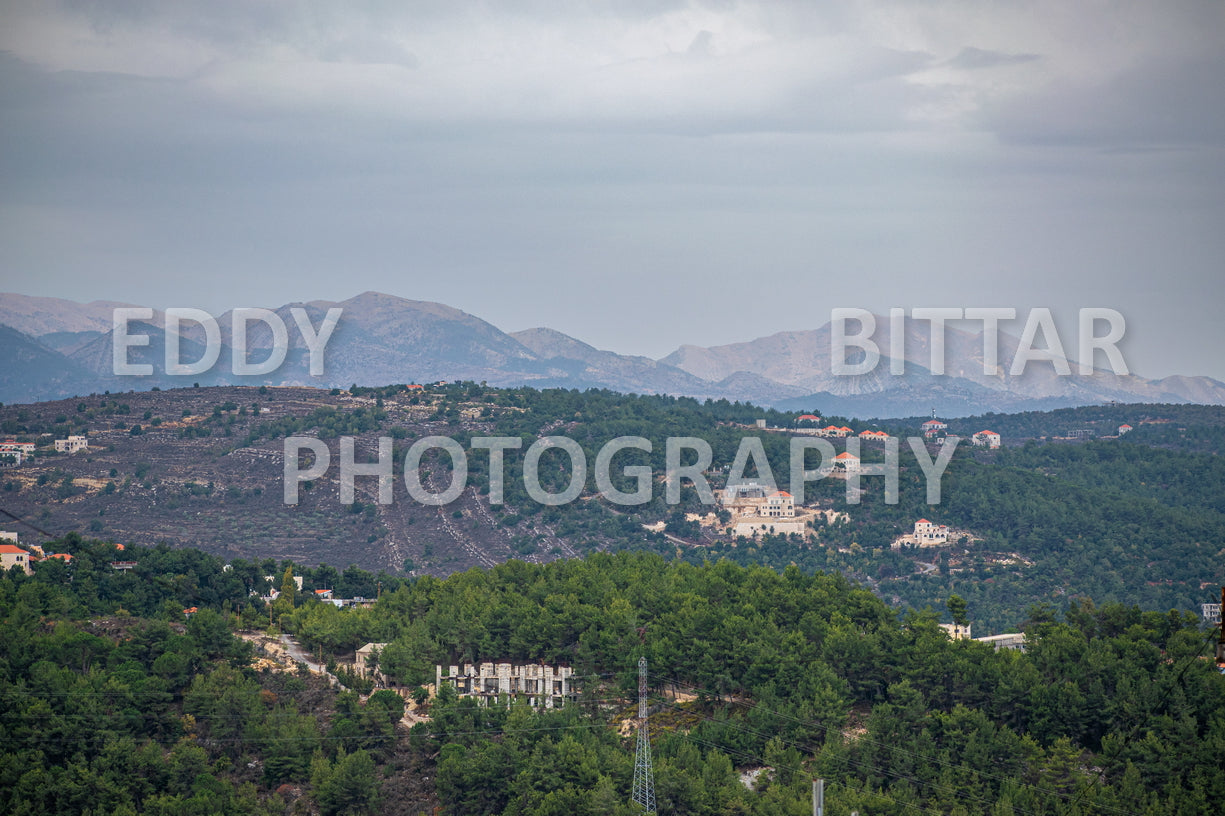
0, 382, 1225, 635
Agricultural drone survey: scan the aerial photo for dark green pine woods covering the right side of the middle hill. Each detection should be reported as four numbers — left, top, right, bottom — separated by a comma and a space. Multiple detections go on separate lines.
387, 383, 1225, 635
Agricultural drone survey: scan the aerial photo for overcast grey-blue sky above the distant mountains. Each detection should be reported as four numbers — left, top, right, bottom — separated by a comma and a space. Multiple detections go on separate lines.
0, 0, 1225, 380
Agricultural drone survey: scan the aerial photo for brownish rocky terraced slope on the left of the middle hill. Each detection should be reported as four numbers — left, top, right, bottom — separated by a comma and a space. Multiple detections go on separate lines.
0, 387, 576, 575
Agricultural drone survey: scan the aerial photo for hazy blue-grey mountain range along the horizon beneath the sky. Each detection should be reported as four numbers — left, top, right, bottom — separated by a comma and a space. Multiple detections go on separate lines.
0, 292, 1225, 417
